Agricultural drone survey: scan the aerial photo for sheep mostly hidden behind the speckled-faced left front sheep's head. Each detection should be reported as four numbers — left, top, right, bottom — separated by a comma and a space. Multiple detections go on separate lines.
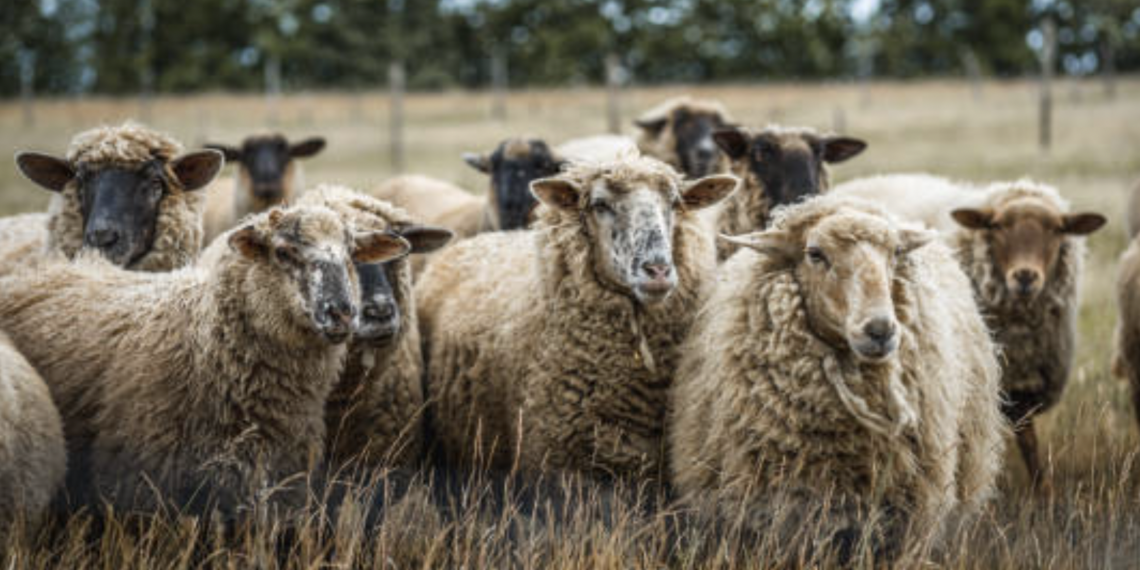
298, 185, 451, 467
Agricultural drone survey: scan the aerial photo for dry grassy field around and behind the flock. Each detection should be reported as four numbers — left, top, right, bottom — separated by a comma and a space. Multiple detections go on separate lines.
0, 79, 1140, 568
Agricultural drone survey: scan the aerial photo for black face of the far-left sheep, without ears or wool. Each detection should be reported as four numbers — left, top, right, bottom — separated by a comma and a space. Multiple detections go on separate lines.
78, 161, 169, 267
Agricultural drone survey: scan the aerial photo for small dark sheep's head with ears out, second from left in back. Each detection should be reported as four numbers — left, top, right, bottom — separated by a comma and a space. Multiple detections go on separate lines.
206, 135, 325, 204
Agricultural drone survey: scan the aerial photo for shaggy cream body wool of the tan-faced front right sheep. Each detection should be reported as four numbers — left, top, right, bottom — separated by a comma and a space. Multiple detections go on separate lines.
669, 198, 1004, 544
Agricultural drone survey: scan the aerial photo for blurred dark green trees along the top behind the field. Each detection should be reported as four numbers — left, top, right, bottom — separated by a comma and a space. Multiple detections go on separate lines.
0, 0, 1140, 96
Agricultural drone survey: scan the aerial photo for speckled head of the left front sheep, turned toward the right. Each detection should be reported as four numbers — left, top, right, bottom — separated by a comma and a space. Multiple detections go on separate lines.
229, 207, 410, 343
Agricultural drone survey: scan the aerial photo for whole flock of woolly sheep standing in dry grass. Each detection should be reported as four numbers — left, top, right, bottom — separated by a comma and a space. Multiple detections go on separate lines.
0, 98, 1126, 560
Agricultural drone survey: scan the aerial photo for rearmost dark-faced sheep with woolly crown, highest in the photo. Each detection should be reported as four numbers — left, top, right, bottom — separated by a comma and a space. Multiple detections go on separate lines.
634, 97, 733, 178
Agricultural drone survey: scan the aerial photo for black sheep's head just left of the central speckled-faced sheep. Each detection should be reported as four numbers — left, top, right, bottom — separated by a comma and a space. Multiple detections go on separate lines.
463, 138, 565, 230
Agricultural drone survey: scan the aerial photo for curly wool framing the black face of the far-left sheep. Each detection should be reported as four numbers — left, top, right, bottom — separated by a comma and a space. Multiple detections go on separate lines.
47, 122, 205, 271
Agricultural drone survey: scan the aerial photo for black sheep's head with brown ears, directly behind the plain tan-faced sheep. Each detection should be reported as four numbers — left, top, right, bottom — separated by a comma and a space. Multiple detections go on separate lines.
713, 128, 866, 217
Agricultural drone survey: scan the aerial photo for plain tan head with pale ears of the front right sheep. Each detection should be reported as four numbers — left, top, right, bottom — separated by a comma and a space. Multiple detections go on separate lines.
724, 204, 933, 363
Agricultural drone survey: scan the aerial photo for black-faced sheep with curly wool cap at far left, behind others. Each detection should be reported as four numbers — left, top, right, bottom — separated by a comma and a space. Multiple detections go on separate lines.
0, 122, 225, 271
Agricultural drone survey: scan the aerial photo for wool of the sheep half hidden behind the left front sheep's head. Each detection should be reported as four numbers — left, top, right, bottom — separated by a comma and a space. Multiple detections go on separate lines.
299, 185, 424, 466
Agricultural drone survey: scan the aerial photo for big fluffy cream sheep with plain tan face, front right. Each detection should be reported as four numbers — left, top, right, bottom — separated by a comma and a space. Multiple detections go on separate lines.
668, 196, 1005, 556
